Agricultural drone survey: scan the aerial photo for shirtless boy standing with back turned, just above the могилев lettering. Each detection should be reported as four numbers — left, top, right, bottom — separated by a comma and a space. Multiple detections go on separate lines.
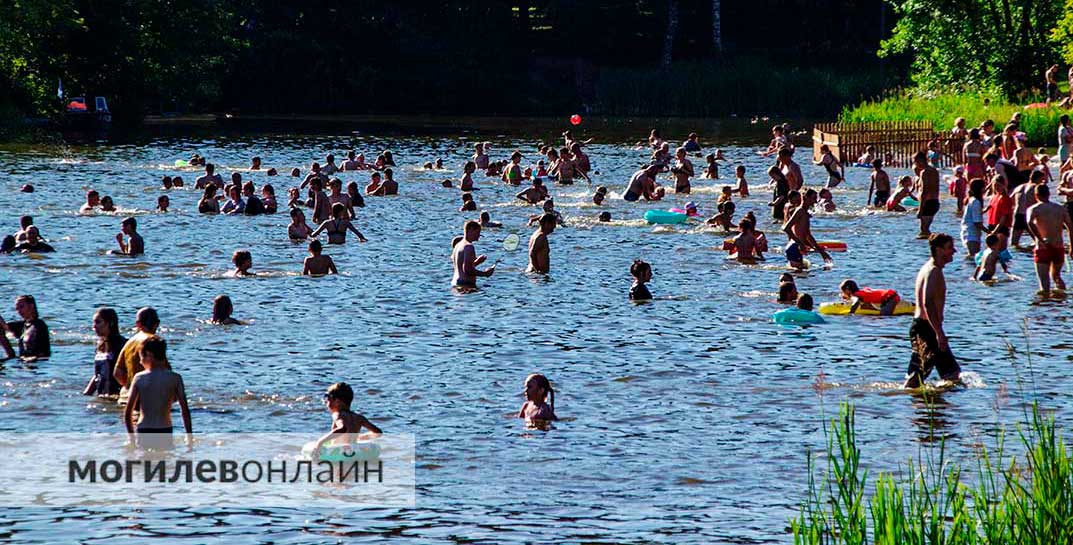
123, 336, 193, 448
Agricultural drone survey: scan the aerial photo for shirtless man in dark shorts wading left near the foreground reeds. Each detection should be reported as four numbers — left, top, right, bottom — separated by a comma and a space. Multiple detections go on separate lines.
902, 233, 961, 388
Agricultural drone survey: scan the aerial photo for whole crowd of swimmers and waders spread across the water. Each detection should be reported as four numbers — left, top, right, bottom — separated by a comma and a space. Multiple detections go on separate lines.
8, 117, 1073, 443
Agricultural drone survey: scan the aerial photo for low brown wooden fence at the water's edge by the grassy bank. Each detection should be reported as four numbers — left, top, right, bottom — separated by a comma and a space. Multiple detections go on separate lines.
812, 121, 965, 167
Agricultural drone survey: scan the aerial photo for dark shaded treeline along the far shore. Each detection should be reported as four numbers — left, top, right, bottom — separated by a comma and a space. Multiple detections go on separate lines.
0, 0, 902, 119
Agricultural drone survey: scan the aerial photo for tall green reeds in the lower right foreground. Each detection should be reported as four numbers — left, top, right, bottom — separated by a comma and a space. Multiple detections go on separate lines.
791, 403, 1073, 545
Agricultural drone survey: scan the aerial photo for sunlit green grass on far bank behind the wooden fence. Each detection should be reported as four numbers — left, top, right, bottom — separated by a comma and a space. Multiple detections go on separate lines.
839, 92, 1070, 147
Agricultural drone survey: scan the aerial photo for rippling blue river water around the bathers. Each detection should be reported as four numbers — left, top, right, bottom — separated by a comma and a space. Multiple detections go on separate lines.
0, 124, 1073, 544
